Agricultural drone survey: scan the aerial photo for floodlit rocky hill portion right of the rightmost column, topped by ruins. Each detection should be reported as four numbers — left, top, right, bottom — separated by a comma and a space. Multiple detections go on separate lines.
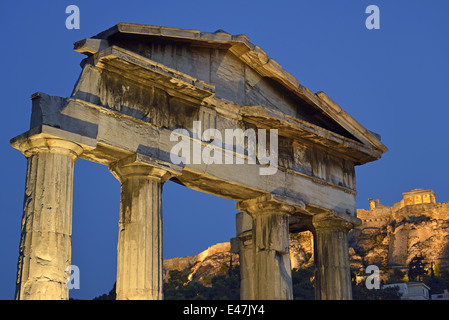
350, 189, 449, 268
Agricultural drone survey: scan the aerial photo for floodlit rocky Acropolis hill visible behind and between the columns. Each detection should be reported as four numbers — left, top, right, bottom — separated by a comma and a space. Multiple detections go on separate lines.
164, 189, 449, 281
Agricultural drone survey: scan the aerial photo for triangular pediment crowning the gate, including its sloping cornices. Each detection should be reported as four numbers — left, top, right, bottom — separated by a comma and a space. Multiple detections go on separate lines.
75, 23, 387, 163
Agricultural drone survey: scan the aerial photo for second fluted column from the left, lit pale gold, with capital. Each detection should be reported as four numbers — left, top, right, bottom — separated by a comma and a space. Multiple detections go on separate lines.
110, 157, 176, 300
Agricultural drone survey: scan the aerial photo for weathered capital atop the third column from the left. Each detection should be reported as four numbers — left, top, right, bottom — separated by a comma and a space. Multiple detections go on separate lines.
236, 194, 296, 216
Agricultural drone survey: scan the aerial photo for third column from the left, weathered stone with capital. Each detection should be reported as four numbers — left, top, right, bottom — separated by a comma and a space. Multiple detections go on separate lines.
237, 196, 295, 300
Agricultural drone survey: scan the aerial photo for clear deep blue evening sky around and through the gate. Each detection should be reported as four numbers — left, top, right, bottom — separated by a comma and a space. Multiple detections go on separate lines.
0, 0, 449, 299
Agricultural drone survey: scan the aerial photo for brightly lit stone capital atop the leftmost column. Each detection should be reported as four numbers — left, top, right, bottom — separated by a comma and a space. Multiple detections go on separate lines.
13, 134, 83, 160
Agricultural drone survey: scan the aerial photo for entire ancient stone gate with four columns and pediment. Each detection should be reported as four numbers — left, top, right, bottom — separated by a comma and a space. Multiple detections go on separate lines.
11, 23, 387, 299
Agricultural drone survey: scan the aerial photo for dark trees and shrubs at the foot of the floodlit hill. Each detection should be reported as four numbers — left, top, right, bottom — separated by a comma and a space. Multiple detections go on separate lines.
94, 257, 449, 300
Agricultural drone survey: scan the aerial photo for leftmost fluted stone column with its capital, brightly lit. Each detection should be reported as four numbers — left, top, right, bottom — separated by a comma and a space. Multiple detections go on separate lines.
14, 135, 83, 300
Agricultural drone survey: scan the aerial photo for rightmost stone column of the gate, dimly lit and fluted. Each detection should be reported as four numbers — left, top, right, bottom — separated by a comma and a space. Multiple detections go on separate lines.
312, 213, 353, 300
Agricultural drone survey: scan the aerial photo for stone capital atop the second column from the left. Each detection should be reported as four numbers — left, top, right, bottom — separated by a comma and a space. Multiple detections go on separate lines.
109, 154, 181, 183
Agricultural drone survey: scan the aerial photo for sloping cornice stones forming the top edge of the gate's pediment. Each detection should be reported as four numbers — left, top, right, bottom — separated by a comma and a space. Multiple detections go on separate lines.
74, 23, 388, 158
